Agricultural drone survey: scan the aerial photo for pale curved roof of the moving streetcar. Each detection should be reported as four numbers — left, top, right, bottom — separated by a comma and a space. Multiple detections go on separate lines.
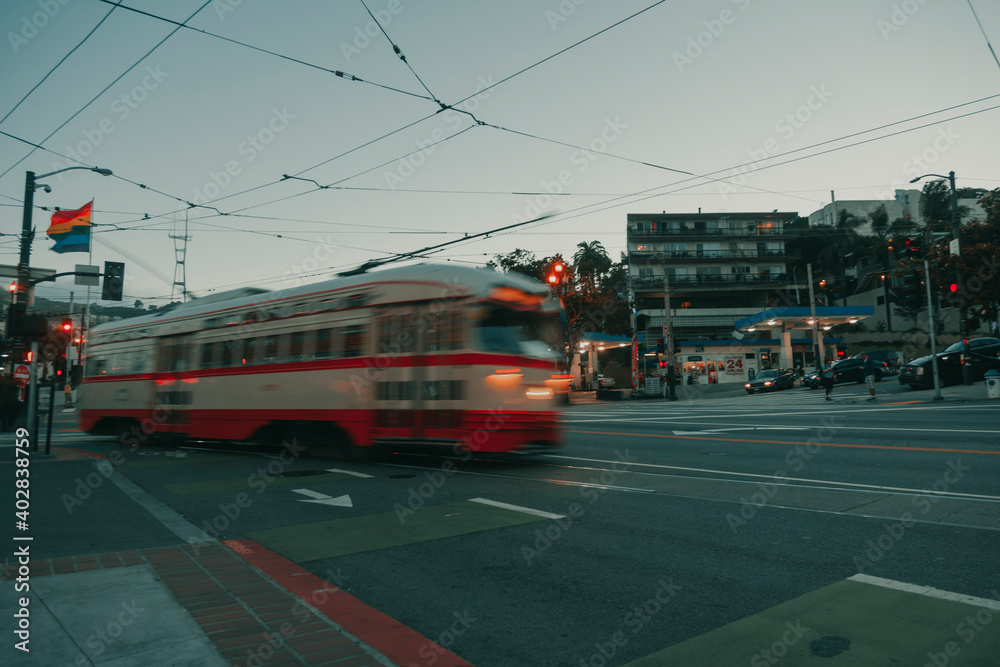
91, 264, 548, 334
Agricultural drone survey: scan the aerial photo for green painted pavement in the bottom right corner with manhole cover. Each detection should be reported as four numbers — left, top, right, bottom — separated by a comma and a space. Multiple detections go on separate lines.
626, 580, 1000, 667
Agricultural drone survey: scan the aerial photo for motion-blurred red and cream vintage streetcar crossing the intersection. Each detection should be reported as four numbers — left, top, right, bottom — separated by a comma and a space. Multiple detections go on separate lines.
77, 264, 569, 454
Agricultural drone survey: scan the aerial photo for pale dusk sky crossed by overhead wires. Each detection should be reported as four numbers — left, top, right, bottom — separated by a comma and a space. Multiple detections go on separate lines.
0, 0, 1000, 305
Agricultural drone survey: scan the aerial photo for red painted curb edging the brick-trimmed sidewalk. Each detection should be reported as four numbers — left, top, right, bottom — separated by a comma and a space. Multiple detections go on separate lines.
222, 540, 474, 667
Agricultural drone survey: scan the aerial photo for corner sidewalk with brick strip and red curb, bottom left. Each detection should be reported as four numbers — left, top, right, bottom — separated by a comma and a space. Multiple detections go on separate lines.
0, 447, 471, 667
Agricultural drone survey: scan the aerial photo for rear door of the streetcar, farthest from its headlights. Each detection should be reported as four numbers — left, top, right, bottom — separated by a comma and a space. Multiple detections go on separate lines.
151, 335, 196, 434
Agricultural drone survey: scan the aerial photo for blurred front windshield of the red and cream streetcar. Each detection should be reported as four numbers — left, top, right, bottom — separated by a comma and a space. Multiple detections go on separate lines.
477, 308, 561, 359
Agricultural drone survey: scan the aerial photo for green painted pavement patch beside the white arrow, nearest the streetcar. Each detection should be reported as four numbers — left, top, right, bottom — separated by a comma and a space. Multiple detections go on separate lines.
246, 501, 545, 563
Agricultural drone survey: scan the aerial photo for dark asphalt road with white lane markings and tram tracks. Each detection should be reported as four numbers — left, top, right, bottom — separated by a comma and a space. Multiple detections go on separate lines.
7, 382, 1000, 667
